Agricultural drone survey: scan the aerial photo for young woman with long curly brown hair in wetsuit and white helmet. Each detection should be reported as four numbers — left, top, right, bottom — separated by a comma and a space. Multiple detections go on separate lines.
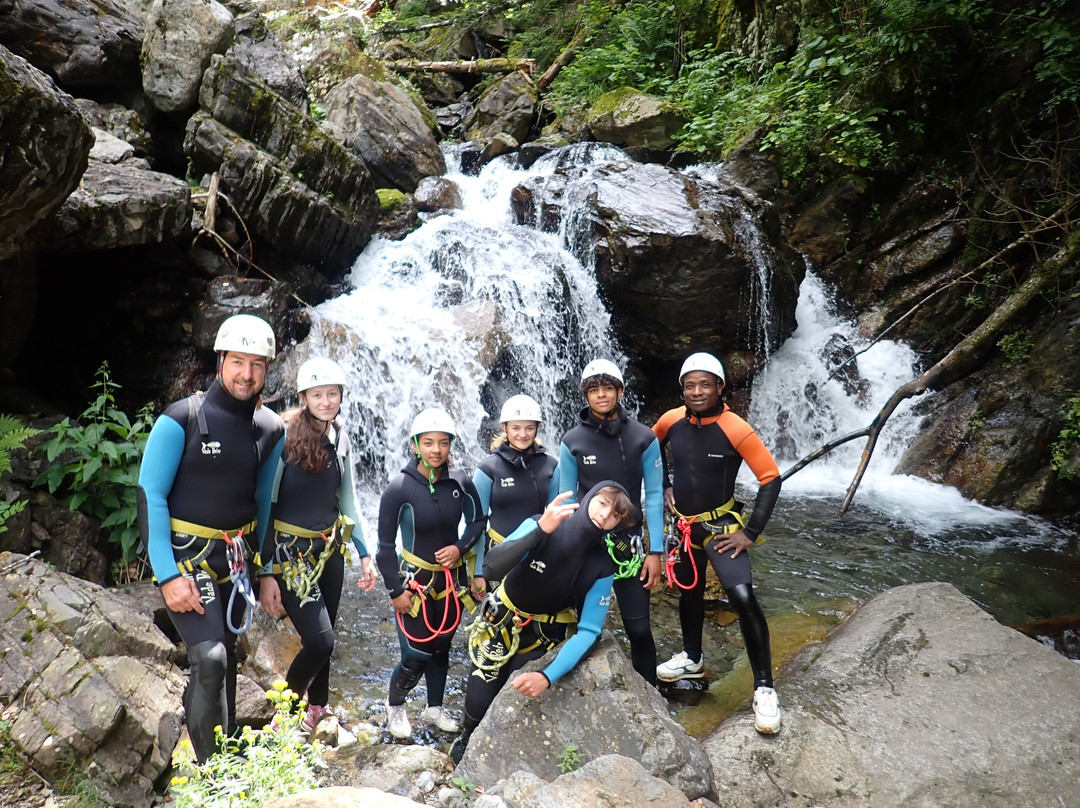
259, 359, 377, 729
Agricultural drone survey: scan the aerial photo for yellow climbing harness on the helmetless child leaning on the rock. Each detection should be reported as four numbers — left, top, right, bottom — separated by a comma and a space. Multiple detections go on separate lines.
465, 585, 578, 671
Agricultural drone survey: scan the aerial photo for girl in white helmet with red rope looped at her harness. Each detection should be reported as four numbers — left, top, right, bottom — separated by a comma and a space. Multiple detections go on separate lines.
377, 408, 484, 738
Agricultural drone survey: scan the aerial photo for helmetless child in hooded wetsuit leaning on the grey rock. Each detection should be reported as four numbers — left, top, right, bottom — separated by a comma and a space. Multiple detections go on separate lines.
450, 480, 637, 763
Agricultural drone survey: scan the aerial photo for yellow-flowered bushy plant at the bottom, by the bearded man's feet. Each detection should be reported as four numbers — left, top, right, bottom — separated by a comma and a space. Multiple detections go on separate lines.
168, 681, 324, 808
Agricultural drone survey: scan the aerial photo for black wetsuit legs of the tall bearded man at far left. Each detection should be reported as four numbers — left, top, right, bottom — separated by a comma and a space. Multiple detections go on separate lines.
166, 540, 247, 762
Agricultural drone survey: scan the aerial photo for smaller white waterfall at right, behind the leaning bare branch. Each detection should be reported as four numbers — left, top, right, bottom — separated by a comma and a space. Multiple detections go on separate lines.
742, 272, 1041, 535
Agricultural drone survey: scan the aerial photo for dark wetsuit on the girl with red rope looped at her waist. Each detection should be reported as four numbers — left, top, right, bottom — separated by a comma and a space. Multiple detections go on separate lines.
376, 458, 485, 706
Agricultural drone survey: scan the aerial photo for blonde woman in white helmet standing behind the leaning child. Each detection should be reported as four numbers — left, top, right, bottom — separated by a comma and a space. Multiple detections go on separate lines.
473, 395, 558, 592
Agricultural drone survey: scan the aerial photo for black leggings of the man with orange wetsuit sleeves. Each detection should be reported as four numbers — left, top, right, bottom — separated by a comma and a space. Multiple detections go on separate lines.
674, 525, 772, 688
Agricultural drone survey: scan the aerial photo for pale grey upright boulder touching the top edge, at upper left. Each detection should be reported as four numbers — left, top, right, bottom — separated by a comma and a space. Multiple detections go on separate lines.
141, 0, 235, 112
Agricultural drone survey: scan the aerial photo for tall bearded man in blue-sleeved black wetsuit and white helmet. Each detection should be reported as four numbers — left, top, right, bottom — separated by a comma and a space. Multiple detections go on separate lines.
139, 314, 285, 760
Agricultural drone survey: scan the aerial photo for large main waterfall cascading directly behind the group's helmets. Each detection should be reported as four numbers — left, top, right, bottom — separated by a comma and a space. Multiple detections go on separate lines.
306, 145, 623, 499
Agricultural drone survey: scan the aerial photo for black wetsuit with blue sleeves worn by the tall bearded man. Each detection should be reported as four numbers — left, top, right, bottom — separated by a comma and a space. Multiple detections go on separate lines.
139, 381, 284, 760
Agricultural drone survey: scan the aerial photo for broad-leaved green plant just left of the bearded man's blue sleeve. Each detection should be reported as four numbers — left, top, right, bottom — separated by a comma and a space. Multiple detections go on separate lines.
33, 362, 152, 563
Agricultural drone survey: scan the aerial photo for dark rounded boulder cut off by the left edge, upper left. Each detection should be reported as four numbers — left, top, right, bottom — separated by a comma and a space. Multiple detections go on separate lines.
0, 45, 94, 262
